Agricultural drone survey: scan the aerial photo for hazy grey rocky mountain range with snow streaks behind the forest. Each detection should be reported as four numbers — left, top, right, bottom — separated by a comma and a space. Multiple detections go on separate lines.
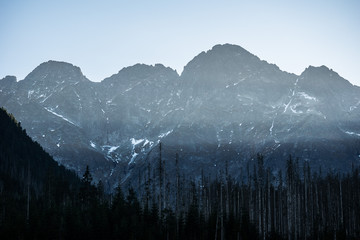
0, 44, 360, 188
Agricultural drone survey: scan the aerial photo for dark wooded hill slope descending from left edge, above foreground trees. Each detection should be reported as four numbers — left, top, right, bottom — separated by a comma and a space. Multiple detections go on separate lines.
0, 108, 79, 197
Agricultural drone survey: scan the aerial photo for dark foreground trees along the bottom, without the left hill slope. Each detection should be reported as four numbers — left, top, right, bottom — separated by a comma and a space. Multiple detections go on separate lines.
0, 160, 360, 239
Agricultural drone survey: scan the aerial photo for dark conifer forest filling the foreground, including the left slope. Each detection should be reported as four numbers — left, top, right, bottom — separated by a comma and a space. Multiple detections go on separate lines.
0, 109, 360, 240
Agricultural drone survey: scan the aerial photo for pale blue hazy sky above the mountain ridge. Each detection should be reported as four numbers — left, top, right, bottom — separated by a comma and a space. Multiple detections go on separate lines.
0, 0, 360, 86
